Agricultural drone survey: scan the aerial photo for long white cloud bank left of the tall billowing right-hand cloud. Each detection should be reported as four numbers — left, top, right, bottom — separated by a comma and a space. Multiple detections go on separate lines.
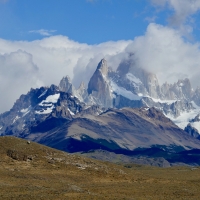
0, 35, 131, 112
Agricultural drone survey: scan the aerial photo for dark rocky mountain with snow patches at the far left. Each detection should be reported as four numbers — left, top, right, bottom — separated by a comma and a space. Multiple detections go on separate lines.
0, 85, 85, 137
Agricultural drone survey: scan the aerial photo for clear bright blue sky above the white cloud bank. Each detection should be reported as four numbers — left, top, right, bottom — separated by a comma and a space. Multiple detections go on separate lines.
0, 0, 181, 44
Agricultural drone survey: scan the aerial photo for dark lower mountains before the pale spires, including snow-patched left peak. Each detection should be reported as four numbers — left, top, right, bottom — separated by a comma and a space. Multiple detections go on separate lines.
0, 81, 200, 154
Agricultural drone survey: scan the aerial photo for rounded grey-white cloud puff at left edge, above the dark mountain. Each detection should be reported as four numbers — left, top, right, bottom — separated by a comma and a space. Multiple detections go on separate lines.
0, 50, 42, 111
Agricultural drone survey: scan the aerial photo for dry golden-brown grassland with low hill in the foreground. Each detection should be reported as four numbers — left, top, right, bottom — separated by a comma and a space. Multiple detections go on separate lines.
0, 137, 200, 200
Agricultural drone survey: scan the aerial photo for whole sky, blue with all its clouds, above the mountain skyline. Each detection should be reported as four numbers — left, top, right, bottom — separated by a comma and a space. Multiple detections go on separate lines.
0, 0, 200, 112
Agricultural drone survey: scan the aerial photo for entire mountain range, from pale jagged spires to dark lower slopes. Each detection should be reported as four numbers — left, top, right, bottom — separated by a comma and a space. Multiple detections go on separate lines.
0, 58, 200, 164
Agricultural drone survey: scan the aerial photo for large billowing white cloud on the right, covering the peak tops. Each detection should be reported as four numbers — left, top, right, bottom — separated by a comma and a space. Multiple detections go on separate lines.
126, 23, 200, 86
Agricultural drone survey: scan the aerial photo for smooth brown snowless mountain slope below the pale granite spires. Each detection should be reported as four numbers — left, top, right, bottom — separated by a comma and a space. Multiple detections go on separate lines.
21, 108, 200, 154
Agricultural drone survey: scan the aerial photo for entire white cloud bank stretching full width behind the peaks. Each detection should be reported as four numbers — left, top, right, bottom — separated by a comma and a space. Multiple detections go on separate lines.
0, 23, 200, 112
